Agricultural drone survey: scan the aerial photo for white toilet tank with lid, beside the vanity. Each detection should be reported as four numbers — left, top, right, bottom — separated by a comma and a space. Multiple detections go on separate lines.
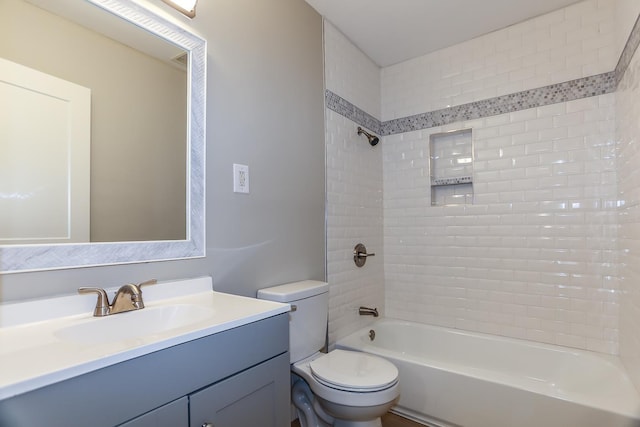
258, 280, 329, 363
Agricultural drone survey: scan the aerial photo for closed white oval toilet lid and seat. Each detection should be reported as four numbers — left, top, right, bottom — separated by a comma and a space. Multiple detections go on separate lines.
309, 350, 398, 392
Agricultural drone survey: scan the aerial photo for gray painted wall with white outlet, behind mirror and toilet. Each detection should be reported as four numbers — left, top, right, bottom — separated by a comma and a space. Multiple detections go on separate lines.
0, 0, 325, 302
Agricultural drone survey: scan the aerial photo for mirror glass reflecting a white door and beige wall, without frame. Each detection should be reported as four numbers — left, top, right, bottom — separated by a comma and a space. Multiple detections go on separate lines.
0, 0, 189, 244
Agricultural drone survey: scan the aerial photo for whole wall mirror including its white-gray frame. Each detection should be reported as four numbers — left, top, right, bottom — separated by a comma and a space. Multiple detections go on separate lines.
0, 0, 207, 273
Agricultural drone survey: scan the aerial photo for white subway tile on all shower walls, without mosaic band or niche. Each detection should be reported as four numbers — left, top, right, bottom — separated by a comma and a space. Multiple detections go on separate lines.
325, 0, 640, 368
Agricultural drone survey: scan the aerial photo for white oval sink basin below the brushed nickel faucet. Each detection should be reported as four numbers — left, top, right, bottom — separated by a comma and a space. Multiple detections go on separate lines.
54, 304, 215, 344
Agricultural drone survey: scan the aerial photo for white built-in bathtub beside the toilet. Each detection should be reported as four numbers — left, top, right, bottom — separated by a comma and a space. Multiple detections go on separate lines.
336, 319, 640, 427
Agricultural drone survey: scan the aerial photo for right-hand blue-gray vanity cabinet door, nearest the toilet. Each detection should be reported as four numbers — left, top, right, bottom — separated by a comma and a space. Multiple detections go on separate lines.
189, 352, 291, 427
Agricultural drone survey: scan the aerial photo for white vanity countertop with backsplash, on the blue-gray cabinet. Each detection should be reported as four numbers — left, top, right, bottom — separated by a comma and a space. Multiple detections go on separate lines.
0, 277, 290, 400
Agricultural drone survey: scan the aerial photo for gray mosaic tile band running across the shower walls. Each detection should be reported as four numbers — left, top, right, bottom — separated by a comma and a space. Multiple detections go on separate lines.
325, 10, 640, 136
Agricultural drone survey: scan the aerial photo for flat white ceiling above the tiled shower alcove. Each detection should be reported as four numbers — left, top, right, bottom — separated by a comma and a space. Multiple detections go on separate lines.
306, 0, 580, 67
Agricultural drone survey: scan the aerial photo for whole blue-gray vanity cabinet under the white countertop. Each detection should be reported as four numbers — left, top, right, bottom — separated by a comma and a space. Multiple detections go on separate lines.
0, 313, 290, 427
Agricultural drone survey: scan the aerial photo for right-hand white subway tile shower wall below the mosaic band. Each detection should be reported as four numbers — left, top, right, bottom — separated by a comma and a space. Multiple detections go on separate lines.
616, 23, 640, 396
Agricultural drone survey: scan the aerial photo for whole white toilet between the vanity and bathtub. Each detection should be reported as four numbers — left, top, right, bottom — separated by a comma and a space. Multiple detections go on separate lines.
258, 280, 400, 427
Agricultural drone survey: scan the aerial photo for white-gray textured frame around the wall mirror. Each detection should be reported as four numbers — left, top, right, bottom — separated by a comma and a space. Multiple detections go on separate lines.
0, 0, 207, 273
